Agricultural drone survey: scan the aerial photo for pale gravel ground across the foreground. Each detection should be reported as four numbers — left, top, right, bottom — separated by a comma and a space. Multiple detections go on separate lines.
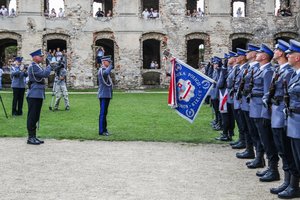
0, 138, 281, 200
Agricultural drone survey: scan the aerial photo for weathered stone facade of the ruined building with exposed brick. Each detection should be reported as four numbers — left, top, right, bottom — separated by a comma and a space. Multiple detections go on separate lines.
0, 0, 300, 89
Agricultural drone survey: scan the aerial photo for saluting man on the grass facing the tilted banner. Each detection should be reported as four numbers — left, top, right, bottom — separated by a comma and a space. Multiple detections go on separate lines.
98, 56, 114, 136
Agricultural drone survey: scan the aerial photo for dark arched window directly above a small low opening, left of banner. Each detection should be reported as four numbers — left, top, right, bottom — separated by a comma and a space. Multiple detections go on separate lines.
143, 39, 160, 69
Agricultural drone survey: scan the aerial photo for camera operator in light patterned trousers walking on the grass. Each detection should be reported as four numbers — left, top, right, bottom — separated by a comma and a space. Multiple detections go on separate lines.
54, 61, 70, 110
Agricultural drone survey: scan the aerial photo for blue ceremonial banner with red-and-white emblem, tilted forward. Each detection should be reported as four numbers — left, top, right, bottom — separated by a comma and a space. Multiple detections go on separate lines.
168, 58, 215, 123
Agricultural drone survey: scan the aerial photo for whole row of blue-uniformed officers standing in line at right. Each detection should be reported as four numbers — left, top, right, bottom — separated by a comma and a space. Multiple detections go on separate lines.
207, 40, 300, 199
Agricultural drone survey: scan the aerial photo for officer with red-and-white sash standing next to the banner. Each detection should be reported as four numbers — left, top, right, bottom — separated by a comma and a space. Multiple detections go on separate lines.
216, 53, 234, 141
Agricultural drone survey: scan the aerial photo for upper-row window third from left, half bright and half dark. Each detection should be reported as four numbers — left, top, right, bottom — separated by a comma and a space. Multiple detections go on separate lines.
93, 0, 113, 18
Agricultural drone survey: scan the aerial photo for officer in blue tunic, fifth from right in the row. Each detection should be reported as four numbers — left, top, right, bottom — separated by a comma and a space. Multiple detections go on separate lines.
234, 48, 255, 159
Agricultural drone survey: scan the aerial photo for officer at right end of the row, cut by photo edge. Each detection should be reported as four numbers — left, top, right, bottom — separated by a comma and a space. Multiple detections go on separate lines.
278, 40, 300, 199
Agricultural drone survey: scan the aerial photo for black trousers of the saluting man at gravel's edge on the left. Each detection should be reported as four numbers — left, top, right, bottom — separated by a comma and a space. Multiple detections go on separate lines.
26, 97, 43, 137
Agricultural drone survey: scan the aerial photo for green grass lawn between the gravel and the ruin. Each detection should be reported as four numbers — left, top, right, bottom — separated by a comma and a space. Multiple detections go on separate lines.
0, 92, 237, 143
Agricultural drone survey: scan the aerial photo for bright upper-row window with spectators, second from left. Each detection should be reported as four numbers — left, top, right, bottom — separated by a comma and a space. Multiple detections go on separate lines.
44, 0, 65, 18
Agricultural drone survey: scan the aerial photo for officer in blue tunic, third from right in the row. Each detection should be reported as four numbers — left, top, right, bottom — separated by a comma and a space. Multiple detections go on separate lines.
249, 44, 280, 182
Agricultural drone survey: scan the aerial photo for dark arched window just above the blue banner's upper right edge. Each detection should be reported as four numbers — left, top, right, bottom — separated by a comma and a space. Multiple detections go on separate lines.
187, 39, 204, 68
